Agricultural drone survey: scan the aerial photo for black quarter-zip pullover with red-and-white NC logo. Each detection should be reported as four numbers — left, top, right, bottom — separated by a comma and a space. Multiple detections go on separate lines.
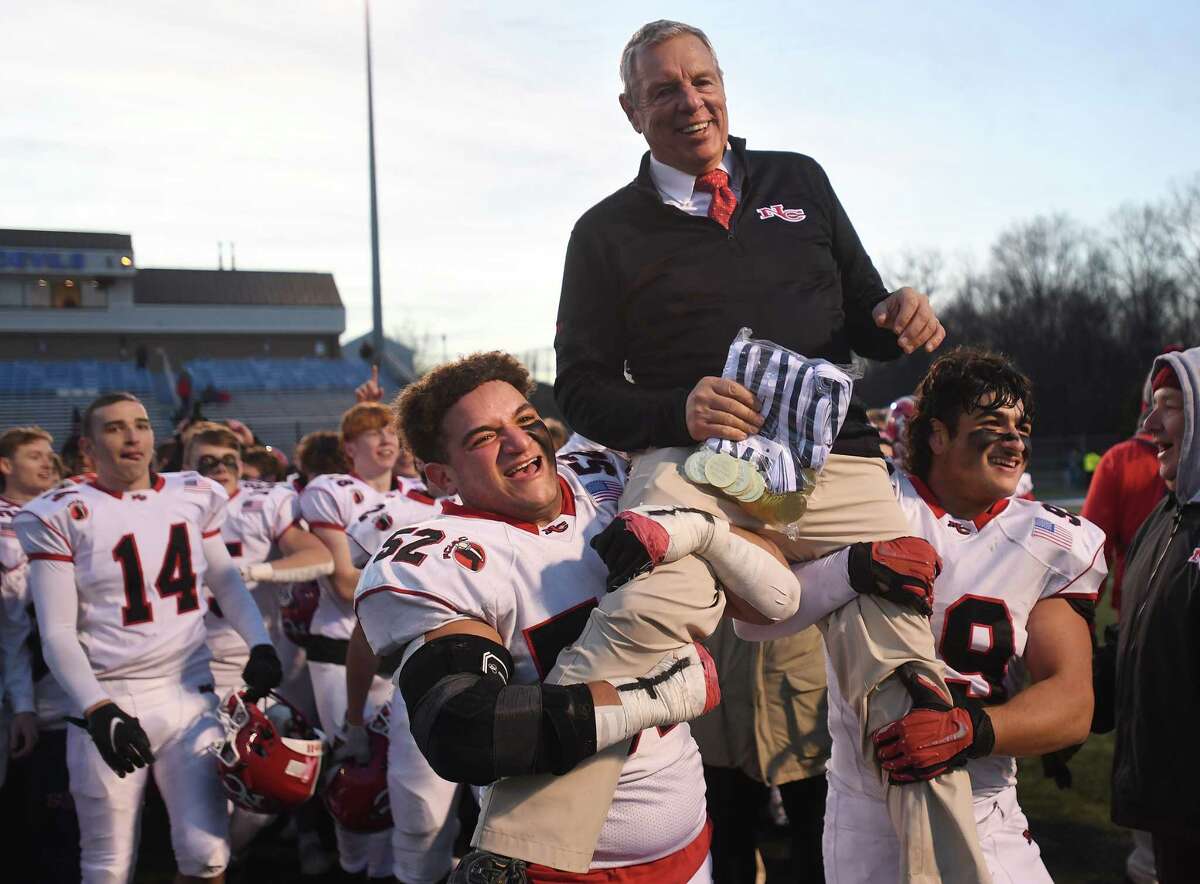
554, 138, 901, 457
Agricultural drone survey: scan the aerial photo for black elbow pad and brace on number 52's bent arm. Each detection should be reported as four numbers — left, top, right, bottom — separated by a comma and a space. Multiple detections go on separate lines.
398, 635, 595, 786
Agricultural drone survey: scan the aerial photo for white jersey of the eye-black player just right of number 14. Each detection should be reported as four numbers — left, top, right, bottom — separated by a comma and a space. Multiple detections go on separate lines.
204, 480, 300, 659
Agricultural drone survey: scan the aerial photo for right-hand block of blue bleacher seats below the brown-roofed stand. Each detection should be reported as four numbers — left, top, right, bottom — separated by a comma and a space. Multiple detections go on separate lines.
184, 357, 365, 393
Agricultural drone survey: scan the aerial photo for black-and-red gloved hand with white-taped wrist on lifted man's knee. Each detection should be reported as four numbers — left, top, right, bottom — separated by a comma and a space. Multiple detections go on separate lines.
592, 506, 714, 593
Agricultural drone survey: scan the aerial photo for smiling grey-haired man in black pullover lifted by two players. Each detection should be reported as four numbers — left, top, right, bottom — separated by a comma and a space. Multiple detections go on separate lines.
476, 22, 986, 880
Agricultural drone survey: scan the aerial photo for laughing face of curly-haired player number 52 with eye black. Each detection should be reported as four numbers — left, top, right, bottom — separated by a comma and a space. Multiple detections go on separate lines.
425, 380, 562, 524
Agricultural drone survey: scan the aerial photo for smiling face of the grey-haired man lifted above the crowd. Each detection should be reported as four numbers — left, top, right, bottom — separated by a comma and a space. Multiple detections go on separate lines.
620, 34, 730, 175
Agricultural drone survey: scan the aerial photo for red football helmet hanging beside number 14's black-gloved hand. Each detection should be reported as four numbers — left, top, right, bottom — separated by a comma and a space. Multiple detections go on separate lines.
212, 691, 325, 813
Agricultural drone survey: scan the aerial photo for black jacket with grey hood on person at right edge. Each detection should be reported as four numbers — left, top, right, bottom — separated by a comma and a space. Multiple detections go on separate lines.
1112, 348, 1200, 831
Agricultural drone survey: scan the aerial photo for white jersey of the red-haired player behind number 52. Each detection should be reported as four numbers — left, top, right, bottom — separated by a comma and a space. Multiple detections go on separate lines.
300, 473, 404, 639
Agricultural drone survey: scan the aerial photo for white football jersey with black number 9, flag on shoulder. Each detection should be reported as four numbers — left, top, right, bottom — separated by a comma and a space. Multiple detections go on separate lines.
829, 474, 1108, 800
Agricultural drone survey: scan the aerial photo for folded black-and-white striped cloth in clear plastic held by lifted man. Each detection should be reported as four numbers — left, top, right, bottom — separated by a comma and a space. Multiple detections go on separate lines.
704, 329, 854, 494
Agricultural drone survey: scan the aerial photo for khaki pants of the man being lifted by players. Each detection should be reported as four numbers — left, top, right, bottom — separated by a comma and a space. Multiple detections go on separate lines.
475, 447, 990, 882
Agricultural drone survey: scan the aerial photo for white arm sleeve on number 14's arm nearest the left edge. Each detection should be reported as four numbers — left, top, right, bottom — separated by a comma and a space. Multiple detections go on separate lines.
29, 559, 110, 710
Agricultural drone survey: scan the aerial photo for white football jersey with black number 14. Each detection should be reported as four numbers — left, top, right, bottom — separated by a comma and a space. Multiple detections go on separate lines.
13, 473, 227, 680
